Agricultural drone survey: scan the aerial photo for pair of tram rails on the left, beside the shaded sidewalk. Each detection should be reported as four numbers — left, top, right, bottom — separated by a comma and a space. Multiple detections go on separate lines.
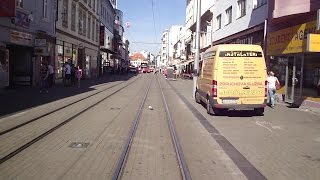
0, 77, 140, 164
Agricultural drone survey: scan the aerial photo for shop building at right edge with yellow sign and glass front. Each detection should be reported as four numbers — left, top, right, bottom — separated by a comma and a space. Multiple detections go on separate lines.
267, 0, 320, 107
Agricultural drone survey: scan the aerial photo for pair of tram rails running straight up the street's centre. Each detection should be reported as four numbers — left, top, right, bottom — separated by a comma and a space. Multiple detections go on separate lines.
112, 75, 191, 180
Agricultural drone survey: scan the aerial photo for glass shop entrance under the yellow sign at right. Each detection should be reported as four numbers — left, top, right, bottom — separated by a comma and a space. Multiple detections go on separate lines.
285, 55, 304, 104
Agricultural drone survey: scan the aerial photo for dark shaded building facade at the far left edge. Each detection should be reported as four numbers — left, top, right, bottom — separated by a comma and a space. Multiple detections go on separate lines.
0, 0, 56, 88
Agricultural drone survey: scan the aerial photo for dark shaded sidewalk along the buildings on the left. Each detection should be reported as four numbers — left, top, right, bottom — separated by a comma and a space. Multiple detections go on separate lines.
0, 74, 134, 117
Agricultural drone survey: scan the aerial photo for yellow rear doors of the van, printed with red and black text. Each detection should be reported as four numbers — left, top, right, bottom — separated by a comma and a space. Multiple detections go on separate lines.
217, 50, 266, 104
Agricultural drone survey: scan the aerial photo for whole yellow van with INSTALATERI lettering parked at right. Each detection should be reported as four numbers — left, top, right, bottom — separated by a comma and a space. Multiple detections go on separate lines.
195, 44, 267, 115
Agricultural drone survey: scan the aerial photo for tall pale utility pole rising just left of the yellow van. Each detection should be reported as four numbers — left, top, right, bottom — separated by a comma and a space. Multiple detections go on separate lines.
192, 0, 201, 98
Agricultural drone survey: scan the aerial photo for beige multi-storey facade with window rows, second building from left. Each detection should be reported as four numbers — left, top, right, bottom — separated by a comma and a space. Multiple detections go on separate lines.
55, 0, 100, 78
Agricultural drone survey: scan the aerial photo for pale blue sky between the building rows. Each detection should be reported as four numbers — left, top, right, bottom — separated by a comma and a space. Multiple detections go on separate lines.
117, 0, 186, 55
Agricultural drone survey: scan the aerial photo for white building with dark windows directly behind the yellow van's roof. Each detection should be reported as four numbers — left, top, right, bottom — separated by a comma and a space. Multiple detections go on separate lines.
212, 0, 268, 47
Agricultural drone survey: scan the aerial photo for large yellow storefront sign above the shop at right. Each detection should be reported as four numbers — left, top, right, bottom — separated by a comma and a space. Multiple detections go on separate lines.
267, 21, 317, 55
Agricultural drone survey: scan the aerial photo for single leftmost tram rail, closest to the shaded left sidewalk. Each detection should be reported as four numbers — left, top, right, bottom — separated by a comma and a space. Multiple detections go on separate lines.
0, 77, 141, 136
